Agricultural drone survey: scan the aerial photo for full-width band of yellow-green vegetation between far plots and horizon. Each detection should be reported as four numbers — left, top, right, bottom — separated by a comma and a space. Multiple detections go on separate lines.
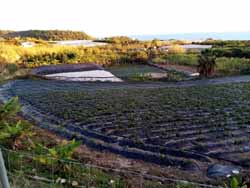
0, 35, 250, 76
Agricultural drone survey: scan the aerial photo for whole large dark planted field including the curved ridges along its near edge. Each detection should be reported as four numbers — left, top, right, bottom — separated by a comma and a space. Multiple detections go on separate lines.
1, 80, 250, 178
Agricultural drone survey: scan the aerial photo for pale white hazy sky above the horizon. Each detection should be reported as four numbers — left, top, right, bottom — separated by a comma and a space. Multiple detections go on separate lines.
0, 0, 250, 37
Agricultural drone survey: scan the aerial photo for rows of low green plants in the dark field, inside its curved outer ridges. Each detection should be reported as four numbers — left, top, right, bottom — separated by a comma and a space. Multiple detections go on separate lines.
3, 81, 250, 167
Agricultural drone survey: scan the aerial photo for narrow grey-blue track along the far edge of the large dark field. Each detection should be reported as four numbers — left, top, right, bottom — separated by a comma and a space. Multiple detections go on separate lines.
4, 76, 250, 91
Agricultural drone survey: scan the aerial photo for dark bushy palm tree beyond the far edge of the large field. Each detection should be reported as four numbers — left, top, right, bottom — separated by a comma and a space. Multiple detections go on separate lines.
197, 55, 216, 78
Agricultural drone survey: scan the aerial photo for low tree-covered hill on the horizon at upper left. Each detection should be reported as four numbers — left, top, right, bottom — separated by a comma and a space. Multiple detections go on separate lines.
0, 30, 92, 41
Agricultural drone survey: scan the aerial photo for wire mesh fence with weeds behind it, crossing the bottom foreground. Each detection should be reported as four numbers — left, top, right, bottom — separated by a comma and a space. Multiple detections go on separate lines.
0, 147, 218, 188
